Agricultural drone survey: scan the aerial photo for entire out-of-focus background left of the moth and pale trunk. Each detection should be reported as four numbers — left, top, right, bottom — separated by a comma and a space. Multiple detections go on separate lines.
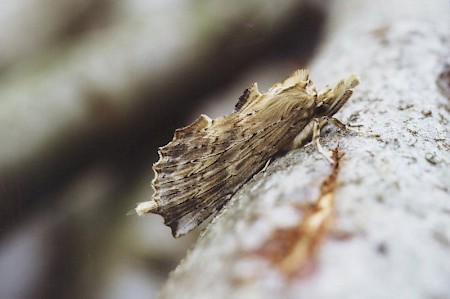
0, 0, 328, 299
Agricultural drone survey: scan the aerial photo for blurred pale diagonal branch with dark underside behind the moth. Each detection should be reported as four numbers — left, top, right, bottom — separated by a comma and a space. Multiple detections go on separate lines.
0, 1, 320, 231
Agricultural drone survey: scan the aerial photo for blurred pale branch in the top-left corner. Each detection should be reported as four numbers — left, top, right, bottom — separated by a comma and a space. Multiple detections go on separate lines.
0, 0, 108, 75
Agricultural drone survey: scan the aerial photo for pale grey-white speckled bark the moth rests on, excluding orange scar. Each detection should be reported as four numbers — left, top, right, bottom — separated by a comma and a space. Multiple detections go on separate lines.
160, 1, 450, 298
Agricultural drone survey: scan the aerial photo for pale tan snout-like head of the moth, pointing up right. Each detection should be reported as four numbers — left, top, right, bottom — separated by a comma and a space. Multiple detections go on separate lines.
315, 74, 359, 117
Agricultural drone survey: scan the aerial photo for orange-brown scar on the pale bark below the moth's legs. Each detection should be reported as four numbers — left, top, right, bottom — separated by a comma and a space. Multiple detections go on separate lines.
257, 148, 343, 277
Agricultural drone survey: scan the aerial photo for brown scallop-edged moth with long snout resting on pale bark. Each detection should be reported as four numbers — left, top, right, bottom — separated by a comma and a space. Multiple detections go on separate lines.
135, 70, 359, 237
